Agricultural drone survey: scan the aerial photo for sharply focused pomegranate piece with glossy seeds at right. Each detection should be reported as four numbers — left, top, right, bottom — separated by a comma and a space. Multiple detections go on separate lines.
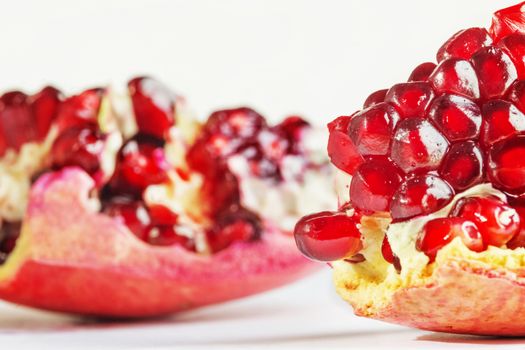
295, 3, 525, 336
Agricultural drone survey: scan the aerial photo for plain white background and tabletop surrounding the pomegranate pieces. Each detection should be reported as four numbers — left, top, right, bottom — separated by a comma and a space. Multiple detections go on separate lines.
0, 0, 525, 349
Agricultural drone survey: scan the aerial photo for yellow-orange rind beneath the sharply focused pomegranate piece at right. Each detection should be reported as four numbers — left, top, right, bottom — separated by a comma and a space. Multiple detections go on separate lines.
336, 249, 525, 336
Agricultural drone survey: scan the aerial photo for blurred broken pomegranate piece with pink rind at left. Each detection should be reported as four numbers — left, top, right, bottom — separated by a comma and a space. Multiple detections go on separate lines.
0, 77, 332, 317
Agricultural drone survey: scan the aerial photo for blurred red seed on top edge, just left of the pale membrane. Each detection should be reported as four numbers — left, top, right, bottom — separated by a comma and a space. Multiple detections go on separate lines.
57, 88, 106, 131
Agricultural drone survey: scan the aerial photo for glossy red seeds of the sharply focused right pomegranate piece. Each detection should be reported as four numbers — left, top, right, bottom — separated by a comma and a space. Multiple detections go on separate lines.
296, 4, 525, 263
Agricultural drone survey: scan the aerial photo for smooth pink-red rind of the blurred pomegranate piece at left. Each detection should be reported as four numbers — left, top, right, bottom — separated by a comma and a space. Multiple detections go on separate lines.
0, 168, 316, 318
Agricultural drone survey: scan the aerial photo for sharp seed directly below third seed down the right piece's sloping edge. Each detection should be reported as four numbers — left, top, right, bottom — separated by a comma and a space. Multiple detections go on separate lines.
385, 82, 434, 118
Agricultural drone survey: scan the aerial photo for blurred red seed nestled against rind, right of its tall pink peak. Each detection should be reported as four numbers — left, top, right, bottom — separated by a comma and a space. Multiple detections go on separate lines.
103, 197, 151, 241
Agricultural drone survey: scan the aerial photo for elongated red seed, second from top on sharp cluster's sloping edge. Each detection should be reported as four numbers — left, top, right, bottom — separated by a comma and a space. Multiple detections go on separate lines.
437, 28, 492, 62
